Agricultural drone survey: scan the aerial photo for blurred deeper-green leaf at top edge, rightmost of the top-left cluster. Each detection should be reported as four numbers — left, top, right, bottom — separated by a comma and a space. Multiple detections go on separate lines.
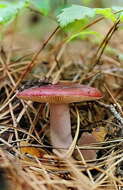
31, 0, 50, 15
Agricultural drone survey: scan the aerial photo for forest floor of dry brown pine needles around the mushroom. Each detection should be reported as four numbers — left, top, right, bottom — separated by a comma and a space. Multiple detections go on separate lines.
0, 17, 123, 190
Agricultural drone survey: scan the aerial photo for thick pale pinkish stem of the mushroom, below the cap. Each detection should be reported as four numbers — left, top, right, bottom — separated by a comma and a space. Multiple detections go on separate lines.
50, 104, 72, 152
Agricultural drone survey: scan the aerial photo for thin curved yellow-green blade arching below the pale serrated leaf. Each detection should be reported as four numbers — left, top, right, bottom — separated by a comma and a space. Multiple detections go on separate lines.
67, 30, 99, 43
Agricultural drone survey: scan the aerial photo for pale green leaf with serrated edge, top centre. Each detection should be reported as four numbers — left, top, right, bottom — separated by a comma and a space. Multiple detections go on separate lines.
57, 5, 95, 27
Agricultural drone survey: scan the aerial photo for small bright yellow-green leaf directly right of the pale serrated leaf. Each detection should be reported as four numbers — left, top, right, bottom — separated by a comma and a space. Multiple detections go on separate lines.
95, 8, 116, 22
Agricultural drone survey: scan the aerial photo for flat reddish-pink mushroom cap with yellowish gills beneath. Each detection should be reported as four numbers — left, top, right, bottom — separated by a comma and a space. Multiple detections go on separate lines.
17, 82, 102, 104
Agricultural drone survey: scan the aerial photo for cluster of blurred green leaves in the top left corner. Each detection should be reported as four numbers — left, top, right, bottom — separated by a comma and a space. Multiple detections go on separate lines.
0, 0, 50, 24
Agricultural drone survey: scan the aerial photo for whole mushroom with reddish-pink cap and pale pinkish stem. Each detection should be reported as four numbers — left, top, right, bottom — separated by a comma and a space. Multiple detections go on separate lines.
17, 82, 102, 157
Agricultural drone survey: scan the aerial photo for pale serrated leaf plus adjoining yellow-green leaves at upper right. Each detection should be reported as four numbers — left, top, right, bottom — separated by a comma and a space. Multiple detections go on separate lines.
57, 5, 123, 28
